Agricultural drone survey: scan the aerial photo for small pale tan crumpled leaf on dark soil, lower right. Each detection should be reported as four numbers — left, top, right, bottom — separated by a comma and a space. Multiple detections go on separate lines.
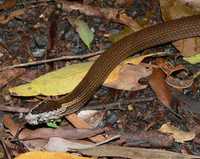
159, 123, 195, 143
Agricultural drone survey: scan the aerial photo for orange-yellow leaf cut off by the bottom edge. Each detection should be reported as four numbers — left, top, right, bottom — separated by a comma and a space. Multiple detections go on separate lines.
15, 151, 91, 159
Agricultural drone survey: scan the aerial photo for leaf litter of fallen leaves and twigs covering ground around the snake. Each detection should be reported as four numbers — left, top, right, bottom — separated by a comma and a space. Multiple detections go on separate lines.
0, 0, 200, 159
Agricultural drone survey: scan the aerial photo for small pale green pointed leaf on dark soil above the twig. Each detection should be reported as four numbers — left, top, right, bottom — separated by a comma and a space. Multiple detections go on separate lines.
75, 19, 94, 48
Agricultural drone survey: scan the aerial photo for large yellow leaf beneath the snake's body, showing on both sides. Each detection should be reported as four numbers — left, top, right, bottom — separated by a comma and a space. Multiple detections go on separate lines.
9, 53, 166, 96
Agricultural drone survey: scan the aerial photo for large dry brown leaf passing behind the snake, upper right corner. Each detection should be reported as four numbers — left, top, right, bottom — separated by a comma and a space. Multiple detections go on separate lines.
160, 0, 200, 57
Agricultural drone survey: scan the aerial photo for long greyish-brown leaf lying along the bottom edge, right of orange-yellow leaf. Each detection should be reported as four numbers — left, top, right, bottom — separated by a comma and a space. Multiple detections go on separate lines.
79, 145, 199, 159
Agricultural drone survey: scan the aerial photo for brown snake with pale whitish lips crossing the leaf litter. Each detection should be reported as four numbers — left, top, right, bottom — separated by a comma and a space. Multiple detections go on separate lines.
25, 15, 200, 124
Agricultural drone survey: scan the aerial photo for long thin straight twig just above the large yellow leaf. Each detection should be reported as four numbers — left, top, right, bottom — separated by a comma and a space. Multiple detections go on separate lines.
0, 50, 104, 72
